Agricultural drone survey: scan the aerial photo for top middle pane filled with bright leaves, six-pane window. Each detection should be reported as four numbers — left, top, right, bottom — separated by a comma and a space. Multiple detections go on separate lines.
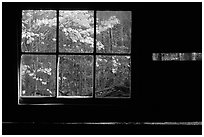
59, 10, 94, 53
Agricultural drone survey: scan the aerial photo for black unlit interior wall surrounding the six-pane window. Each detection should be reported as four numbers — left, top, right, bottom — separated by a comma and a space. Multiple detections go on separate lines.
2, 3, 202, 133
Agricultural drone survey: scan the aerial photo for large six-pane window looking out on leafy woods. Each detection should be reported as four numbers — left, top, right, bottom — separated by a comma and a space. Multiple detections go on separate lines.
19, 10, 132, 104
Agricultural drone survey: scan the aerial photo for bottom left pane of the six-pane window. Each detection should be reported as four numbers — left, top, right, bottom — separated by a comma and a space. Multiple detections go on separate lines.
20, 55, 56, 96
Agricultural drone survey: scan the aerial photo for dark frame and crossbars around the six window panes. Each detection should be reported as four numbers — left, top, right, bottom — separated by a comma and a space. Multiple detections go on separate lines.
18, 8, 132, 105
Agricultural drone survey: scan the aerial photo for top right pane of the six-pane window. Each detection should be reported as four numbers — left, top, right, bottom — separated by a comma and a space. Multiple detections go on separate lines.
96, 11, 132, 53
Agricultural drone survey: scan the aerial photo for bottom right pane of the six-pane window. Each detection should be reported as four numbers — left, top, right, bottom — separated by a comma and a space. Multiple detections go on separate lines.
95, 56, 131, 97
